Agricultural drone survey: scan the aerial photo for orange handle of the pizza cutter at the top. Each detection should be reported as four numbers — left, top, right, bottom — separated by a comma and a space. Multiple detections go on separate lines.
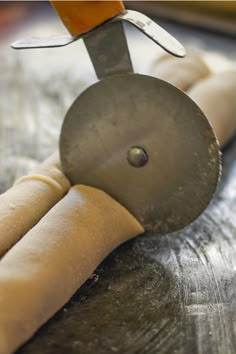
51, 0, 124, 36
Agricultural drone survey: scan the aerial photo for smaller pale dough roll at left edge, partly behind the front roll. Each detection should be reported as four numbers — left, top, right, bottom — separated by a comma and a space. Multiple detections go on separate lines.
0, 154, 70, 257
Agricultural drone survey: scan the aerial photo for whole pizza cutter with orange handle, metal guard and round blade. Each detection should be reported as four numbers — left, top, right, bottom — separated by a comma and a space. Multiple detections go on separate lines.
13, 1, 220, 233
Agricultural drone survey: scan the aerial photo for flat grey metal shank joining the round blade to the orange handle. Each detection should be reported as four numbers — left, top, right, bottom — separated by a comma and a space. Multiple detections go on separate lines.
84, 21, 133, 79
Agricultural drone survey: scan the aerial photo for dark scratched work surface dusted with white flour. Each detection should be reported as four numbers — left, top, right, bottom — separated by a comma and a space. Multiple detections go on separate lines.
0, 6, 236, 354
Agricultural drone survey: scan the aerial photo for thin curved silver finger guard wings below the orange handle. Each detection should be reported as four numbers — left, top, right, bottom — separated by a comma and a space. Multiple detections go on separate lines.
11, 10, 186, 57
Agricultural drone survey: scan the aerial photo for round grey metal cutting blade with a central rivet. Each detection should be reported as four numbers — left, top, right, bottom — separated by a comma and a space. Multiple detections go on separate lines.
60, 74, 220, 233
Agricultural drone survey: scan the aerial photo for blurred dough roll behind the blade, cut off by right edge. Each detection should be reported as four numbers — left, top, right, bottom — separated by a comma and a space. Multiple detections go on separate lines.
188, 71, 236, 146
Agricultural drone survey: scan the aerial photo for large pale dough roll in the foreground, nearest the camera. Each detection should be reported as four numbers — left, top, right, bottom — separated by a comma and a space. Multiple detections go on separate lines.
0, 186, 144, 354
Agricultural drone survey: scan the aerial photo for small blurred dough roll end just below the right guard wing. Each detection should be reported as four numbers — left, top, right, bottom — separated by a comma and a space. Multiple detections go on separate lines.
151, 52, 211, 91
